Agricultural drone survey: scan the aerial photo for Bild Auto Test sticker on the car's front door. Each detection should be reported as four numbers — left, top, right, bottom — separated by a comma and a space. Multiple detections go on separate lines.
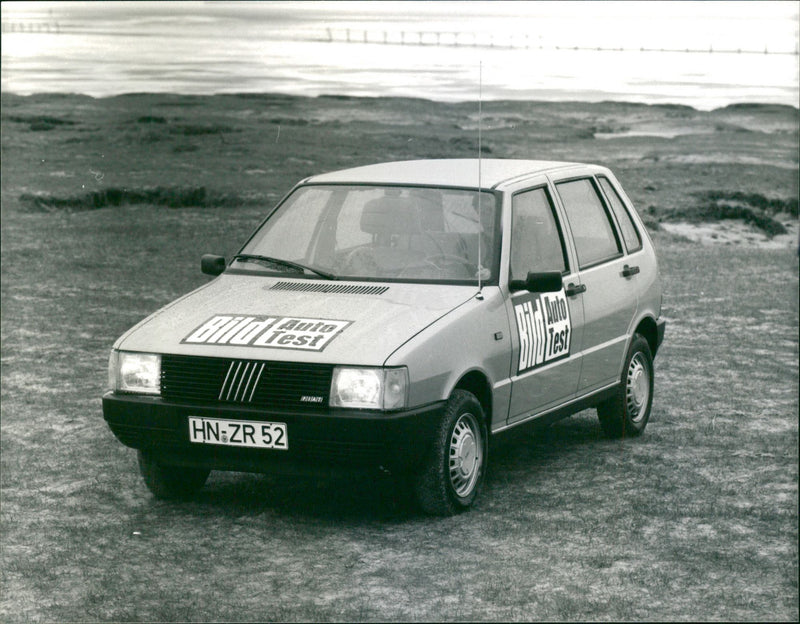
514, 290, 572, 373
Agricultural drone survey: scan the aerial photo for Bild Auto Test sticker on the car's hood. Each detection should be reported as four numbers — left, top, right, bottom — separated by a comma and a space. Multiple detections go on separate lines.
187, 314, 351, 351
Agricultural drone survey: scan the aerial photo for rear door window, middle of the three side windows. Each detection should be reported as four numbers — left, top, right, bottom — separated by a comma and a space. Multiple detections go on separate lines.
556, 178, 622, 269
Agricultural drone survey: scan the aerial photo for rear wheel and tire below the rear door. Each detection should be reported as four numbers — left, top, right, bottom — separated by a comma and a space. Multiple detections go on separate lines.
597, 334, 653, 438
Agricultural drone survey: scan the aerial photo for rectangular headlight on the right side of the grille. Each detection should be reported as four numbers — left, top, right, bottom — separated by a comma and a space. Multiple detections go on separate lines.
329, 366, 408, 410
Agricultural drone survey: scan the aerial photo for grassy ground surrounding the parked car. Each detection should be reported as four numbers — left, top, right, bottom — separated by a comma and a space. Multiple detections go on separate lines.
0, 91, 798, 622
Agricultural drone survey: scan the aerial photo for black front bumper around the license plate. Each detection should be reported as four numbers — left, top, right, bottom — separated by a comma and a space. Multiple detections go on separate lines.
103, 392, 445, 474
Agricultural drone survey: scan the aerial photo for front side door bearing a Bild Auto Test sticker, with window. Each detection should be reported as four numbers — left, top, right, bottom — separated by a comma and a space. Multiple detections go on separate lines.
507, 183, 583, 423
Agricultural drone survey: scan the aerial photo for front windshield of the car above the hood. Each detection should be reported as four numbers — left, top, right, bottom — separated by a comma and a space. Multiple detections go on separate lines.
235, 185, 499, 283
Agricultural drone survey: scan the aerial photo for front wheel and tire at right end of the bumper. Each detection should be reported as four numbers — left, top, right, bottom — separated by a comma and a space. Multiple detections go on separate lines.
414, 390, 489, 516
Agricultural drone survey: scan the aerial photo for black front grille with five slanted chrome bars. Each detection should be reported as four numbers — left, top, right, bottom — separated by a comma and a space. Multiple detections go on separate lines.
161, 355, 333, 410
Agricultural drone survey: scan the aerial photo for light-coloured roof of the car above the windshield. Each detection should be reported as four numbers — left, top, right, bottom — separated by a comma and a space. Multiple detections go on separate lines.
304, 158, 589, 189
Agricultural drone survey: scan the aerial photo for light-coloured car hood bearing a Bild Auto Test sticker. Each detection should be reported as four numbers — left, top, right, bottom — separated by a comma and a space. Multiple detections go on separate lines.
115, 274, 476, 366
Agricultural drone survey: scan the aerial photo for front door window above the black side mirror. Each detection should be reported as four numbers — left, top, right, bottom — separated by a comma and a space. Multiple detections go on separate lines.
511, 188, 567, 279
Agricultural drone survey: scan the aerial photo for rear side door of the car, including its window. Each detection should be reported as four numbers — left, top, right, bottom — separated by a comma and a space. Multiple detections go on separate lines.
554, 176, 638, 395
